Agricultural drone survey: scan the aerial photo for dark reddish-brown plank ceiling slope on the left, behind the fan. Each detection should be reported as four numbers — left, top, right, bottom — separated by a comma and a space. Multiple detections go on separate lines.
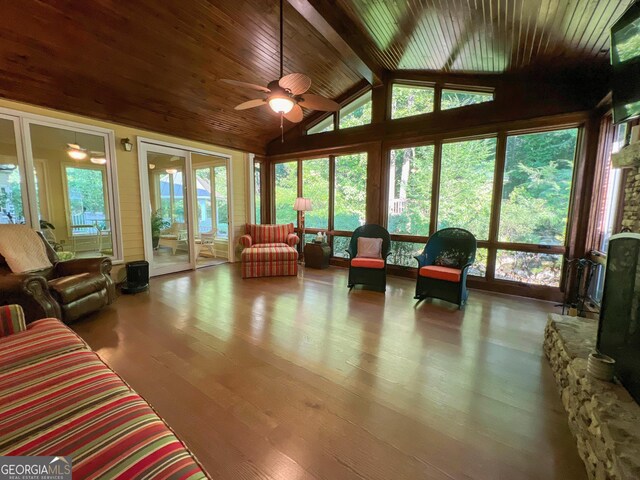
0, 0, 360, 152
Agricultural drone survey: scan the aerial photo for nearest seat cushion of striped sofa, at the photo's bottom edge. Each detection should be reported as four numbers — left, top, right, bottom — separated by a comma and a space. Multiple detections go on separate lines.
0, 393, 208, 480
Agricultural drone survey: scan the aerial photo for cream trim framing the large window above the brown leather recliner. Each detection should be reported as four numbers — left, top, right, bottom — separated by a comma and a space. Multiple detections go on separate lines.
0, 107, 124, 264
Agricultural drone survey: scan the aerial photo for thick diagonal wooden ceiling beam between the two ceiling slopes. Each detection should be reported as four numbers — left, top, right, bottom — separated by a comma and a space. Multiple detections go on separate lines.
287, 0, 383, 85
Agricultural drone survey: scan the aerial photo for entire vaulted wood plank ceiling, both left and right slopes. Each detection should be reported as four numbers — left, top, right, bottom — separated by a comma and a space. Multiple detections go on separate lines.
0, 0, 632, 152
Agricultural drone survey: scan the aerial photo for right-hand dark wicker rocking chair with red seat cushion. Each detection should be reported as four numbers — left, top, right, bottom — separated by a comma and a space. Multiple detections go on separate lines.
414, 228, 477, 308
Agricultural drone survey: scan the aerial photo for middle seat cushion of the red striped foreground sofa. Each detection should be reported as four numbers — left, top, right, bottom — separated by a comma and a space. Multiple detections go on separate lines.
0, 350, 130, 451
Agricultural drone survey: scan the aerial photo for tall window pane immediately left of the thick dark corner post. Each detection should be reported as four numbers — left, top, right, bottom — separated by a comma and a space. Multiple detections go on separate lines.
333, 153, 367, 231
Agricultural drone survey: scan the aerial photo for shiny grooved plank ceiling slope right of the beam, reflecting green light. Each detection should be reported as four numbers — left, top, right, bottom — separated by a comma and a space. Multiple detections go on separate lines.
336, 0, 633, 73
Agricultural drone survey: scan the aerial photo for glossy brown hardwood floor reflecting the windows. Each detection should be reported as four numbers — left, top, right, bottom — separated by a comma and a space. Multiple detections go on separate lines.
74, 264, 586, 480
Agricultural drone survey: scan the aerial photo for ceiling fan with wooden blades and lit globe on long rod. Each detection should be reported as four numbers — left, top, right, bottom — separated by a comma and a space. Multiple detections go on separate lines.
221, 0, 340, 138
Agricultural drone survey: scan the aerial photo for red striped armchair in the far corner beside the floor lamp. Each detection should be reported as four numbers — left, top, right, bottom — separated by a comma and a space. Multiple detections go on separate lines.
239, 223, 299, 278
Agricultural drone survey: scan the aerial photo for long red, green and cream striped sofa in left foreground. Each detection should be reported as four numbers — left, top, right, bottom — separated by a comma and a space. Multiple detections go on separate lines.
0, 306, 209, 480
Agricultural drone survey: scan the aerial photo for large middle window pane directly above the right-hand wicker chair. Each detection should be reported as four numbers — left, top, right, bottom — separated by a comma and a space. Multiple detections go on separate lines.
438, 138, 496, 240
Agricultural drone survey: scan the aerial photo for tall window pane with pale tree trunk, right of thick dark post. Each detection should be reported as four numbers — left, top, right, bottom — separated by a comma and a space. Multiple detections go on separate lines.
387, 145, 434, 236
